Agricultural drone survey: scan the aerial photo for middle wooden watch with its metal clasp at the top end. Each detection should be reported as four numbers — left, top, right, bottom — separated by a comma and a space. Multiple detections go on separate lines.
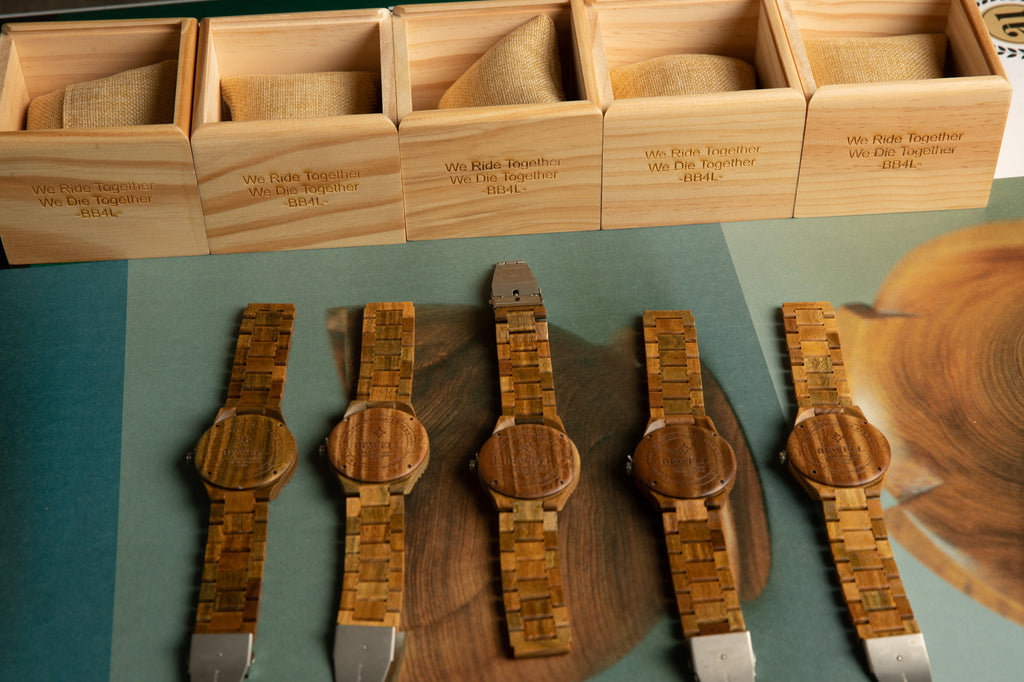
476, 261, 580, 657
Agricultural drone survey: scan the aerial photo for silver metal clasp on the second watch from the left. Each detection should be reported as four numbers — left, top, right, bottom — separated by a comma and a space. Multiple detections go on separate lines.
334, 625, 406, 682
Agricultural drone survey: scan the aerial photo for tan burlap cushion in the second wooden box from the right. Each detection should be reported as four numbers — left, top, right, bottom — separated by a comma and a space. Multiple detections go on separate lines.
609, 54, 756, 99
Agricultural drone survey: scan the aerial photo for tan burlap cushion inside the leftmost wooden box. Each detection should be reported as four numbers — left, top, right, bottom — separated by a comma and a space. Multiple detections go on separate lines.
27, 59, 178, 130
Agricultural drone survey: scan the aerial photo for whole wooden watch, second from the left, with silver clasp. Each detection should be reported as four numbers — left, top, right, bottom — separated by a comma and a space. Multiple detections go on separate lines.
327, 302, 429, 682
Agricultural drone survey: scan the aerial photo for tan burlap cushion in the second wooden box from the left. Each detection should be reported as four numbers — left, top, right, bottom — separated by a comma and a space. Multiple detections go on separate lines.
220, 71, 381, 121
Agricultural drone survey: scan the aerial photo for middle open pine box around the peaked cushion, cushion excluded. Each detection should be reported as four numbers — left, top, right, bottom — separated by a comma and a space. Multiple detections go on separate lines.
394, 0, 601, 240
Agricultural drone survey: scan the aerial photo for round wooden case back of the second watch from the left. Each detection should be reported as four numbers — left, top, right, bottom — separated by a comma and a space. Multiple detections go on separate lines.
327, 408, 430, 483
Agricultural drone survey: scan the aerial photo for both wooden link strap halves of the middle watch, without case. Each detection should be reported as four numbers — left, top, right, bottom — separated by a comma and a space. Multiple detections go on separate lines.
495, 296, 571, 657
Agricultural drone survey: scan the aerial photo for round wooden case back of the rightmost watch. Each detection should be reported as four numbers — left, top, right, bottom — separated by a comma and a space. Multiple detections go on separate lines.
785, 414, 890, 487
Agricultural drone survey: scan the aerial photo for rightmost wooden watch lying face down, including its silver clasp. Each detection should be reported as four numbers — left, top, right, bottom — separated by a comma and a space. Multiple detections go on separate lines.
782, 302, 932, 682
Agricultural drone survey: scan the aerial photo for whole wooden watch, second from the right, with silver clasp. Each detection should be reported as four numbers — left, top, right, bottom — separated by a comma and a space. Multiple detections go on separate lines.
631, 310, 754, 682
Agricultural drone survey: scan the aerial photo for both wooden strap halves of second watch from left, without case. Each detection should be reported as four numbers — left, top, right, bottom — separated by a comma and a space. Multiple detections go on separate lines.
338, 302, 416, 629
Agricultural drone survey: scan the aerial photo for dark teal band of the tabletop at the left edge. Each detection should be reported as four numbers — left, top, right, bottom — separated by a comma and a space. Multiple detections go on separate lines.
0, 262, 128, 681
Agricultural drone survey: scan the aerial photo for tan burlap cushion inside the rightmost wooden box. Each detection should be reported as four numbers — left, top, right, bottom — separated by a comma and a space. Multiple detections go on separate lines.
804, 33, 946, 87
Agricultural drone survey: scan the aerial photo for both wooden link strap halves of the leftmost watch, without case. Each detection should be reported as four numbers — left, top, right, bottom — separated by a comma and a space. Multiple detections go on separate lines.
196, 303, 295, 634
